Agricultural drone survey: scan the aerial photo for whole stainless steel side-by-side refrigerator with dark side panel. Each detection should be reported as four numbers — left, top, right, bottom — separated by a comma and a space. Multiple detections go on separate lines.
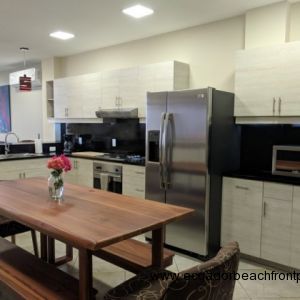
146, 88, 239, 256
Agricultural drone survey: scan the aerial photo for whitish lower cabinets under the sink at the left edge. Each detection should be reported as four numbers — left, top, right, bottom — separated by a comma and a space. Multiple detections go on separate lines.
0, 158, 49, 180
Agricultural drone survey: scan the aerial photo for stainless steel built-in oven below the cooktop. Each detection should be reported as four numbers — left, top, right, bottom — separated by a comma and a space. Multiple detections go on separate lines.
93, 162, 122, 194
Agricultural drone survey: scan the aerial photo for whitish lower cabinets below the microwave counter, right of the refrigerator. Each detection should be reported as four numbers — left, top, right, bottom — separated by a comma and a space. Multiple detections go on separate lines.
221, 177, 300, 268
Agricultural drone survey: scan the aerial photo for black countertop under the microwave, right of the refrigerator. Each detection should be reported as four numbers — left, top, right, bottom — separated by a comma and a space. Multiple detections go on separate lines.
223, 171, 300, 185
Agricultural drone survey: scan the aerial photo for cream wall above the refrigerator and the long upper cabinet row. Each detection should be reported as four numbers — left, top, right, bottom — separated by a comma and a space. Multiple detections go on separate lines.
61, 16, 244, 91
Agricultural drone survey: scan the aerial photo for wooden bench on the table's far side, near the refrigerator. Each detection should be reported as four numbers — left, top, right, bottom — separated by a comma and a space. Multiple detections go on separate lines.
93, 239, 174, 274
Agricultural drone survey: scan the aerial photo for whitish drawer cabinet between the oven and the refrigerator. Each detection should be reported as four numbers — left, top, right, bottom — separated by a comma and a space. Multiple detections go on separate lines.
122, 165, 145, 198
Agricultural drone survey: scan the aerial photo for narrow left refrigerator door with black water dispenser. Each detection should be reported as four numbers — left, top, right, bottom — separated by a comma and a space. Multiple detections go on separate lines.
146, 92, 167, 203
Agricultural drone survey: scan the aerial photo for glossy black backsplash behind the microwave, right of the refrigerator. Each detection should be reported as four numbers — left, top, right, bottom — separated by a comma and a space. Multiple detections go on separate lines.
240, 125, 300, 172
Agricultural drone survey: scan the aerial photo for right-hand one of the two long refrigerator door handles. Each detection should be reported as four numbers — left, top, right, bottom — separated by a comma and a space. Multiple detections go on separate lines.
164, 113, 173, 189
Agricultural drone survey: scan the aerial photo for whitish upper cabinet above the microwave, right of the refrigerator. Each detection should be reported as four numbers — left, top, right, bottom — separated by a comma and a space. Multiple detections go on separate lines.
234, 42, 300, 117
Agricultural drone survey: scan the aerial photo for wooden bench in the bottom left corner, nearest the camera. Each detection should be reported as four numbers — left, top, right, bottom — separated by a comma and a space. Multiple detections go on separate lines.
0, 238, 79, 300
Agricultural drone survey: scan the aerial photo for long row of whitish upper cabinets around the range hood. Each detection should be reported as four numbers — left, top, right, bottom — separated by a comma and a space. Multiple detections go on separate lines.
54, 61, 189, 119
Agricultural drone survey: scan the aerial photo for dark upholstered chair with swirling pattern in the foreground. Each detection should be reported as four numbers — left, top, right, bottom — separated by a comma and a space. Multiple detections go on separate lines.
104, 242, 240, 300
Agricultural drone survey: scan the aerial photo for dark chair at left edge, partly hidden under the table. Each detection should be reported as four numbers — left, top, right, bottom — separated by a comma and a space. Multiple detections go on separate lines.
0, 216, 39, 257
